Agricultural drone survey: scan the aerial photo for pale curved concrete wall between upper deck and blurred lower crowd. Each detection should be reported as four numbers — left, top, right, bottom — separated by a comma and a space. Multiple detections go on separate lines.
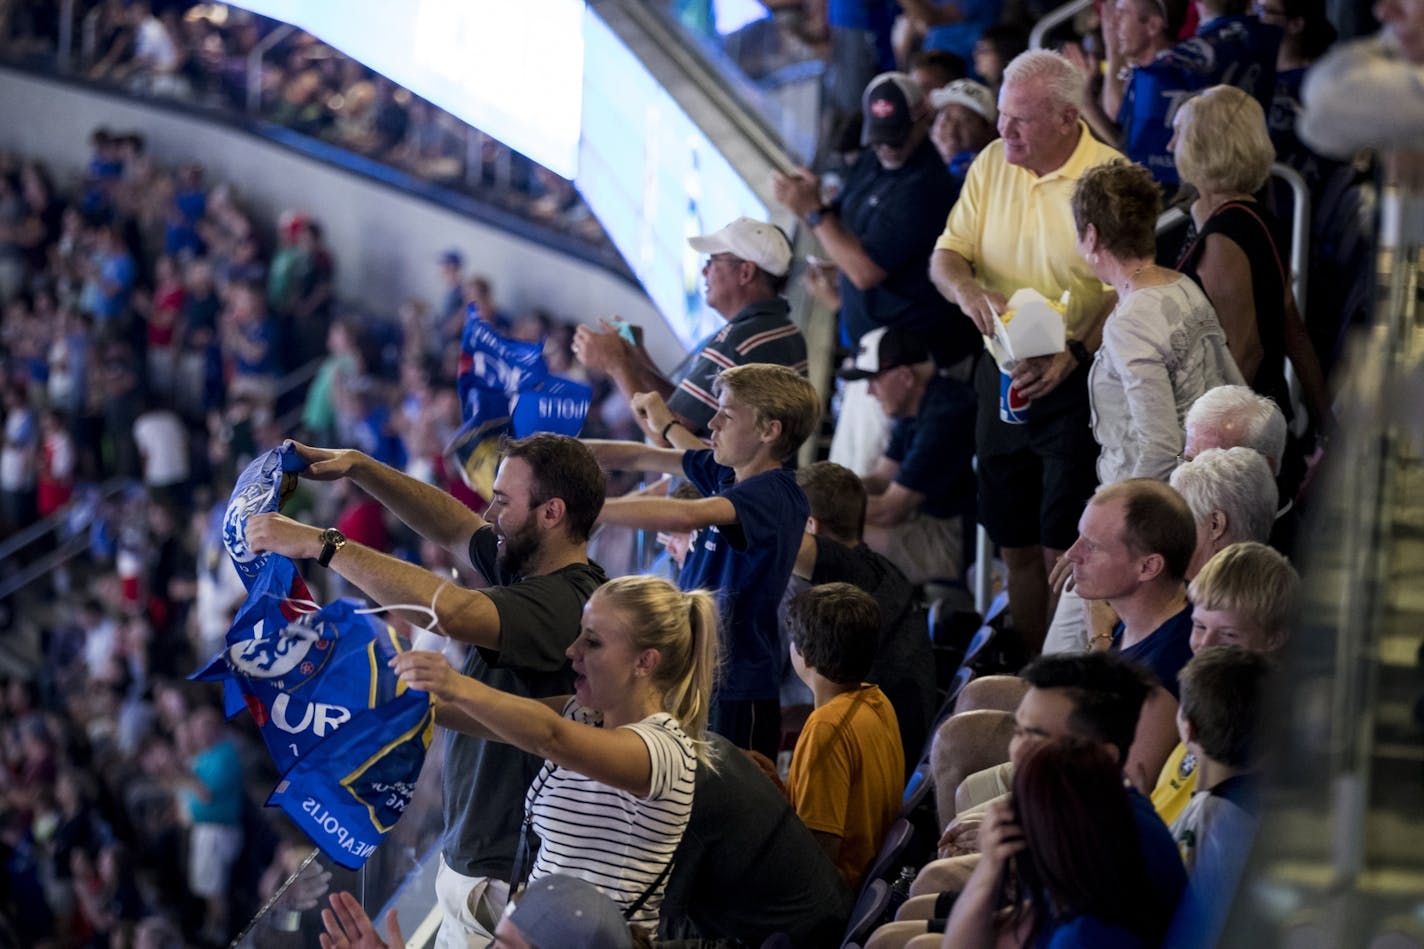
0, 68, 682, 368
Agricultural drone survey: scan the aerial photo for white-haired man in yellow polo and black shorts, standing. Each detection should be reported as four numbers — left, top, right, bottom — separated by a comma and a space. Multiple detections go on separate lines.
930, 50, 1121, 654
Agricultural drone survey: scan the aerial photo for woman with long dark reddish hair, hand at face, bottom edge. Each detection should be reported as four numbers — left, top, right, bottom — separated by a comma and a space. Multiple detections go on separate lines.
941, 738, 1175, 949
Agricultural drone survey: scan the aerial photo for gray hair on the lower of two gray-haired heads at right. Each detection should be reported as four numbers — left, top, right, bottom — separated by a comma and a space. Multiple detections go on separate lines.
1171, 447, 1279, 544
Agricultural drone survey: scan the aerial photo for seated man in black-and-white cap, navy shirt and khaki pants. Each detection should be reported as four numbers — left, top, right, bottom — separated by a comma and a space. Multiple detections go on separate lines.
836, 326, 975, 583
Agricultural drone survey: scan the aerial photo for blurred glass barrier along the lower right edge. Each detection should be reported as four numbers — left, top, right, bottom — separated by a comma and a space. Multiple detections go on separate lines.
1220, 149, 1424, 949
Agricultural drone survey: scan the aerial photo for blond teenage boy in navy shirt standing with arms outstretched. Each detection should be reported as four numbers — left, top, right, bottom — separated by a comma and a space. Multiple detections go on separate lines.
587, 363, 820, 757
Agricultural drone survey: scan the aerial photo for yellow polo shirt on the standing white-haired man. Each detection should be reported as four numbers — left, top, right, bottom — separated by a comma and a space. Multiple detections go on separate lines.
934, 120, 1122, 339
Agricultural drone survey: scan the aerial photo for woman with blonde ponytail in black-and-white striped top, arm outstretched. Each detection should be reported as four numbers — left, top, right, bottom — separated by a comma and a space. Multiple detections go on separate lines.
392, 577, 718, 926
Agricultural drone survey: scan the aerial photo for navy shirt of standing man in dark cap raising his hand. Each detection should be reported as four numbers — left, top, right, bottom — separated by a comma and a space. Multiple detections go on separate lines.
836, 140, 980, 365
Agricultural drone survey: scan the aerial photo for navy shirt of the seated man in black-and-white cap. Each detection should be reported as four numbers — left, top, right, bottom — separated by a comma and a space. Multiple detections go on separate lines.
886, 370, 975, 517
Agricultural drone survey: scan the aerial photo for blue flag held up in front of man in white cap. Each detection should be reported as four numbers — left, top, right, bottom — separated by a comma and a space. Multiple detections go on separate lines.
446, 304, 592, 500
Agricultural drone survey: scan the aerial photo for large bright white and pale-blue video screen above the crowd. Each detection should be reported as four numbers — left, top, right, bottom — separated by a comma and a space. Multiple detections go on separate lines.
239, 0, 768, 346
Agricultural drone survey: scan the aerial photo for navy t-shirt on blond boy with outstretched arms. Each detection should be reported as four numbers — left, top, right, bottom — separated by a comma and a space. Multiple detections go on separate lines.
678, 449, 810, 701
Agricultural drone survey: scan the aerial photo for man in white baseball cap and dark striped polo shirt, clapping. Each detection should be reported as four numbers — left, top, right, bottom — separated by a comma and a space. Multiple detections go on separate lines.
574, 218, 806, 438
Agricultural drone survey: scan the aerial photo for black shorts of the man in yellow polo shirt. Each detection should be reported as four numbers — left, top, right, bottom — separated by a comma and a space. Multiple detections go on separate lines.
974, 359, 1098, 550
